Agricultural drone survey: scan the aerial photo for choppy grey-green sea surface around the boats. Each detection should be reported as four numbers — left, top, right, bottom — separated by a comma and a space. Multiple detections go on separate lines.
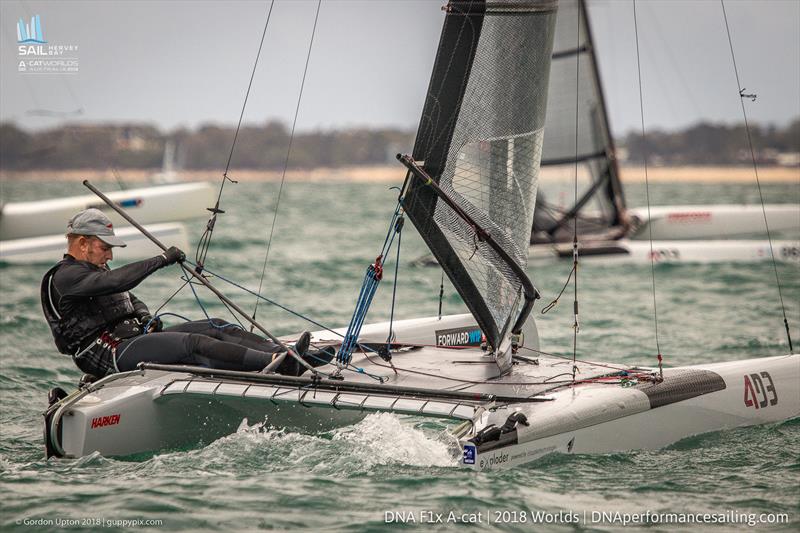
0, 178, 800, 531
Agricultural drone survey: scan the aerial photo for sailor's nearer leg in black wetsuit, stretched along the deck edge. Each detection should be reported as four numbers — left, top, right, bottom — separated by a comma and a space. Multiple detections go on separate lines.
112, 331, 273, 372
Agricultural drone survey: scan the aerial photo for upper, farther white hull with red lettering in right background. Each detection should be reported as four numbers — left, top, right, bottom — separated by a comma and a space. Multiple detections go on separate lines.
628, 204, 800, 241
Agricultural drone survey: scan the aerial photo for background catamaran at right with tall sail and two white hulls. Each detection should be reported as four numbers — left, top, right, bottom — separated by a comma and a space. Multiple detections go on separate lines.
531, 0, 800, 262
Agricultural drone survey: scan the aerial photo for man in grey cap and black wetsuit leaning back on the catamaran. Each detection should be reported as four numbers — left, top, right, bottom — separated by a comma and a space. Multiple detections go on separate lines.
41, 209, 333, 378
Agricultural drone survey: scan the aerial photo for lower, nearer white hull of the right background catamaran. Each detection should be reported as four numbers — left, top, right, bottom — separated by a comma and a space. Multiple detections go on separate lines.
529, 239, 800, 264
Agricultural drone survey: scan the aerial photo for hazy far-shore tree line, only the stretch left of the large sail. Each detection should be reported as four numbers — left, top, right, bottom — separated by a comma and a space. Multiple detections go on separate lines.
0, 122, 414, 170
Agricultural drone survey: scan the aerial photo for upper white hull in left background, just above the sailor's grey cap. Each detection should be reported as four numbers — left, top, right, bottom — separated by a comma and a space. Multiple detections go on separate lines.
0, 183, 214, 241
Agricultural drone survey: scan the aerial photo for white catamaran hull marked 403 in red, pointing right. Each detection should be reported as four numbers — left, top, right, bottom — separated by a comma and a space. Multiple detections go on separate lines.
462, 355, 800, 470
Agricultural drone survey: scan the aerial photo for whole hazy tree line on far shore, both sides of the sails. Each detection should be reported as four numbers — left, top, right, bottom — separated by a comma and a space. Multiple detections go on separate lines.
0, 118, 800, 170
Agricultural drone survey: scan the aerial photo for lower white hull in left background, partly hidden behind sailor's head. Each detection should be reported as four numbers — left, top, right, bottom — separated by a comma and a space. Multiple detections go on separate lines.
0, 223, 189, 264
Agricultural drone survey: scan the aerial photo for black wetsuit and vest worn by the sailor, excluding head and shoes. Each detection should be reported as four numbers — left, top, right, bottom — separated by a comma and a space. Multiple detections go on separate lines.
41, 254, 280, 377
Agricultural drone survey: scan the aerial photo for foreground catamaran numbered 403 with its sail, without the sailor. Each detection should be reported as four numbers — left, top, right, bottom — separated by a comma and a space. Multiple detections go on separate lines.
44, 0, 800, 470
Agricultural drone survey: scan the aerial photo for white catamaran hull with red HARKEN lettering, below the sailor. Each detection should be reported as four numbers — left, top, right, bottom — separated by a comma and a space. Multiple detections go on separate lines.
45, 370, 476, 457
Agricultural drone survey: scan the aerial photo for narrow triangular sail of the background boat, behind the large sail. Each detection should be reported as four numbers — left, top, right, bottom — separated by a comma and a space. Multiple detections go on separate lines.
531, 0, 625, 243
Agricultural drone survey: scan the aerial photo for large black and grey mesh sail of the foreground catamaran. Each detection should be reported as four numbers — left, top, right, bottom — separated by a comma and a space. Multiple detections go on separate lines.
404, 0, 556, 348
